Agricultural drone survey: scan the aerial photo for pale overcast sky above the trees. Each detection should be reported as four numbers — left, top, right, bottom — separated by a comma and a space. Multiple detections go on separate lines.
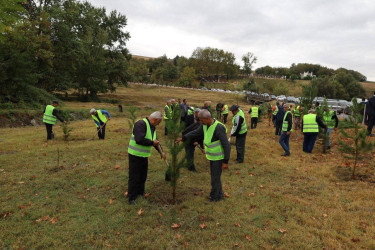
89, 0, 375, 81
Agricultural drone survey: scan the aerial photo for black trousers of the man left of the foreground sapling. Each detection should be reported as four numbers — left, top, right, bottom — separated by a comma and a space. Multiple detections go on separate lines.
128, 154, 148, 201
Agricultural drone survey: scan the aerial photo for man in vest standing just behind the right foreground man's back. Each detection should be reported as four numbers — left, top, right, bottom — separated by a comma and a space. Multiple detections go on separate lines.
229, 105, 247, 163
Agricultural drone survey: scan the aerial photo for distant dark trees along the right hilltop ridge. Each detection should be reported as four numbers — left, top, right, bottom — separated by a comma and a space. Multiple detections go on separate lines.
255, 63, 367, 82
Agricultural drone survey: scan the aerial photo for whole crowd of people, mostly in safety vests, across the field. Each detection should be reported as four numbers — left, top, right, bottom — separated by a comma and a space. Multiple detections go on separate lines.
43, 93, 375, 204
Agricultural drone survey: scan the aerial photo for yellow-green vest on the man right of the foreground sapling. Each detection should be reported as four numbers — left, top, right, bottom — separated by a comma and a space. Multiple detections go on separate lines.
203, 120, 226, 161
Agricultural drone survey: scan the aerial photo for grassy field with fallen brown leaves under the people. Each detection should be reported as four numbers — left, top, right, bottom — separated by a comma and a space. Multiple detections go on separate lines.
0, 85, 375, 249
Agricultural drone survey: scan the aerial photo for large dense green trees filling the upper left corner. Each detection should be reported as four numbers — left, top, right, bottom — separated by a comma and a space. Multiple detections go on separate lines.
0, 0, 130, 106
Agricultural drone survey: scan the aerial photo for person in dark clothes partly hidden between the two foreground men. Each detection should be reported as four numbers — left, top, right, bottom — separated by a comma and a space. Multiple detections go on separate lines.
182, 108, 203, 172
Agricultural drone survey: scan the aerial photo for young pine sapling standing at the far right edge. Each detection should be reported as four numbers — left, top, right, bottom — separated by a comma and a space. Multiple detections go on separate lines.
339, 98, 375, 179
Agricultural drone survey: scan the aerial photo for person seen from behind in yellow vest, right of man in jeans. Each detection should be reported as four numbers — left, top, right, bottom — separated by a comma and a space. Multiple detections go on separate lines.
302, 109, 327, 153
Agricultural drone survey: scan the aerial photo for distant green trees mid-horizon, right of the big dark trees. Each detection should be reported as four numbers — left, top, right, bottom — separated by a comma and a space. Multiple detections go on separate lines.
129, 47, 257, 86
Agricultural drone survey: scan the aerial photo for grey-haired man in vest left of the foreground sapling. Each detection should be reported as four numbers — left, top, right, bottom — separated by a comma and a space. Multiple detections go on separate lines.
128, 111, 166, 205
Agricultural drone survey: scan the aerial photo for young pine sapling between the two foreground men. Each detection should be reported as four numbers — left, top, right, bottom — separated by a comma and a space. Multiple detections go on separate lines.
166, 108, 187, 204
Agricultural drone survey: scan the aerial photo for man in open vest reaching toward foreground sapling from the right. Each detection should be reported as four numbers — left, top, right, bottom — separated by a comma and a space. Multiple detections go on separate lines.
176, 110, 230, 202
